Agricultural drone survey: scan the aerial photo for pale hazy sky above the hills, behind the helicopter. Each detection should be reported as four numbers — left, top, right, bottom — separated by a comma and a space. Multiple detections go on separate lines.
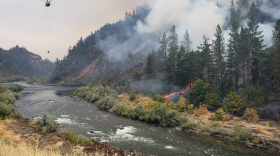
0, 0, 149, 61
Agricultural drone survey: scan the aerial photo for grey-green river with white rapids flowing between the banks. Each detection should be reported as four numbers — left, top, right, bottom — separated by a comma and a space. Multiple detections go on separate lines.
13, 82, 275, 156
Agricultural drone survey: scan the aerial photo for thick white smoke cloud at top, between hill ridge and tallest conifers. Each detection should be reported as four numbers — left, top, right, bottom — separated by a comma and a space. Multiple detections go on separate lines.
136, 0, 230, 49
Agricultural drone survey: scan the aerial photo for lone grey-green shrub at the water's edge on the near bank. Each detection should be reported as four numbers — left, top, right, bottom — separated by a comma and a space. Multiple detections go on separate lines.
42, 113, 57, 133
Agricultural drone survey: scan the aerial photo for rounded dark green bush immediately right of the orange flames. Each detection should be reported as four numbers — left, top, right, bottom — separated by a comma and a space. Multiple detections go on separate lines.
188, 79, 211, 104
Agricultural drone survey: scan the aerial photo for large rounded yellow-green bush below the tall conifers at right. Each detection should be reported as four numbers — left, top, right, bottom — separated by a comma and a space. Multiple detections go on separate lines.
223, 92, 244, 113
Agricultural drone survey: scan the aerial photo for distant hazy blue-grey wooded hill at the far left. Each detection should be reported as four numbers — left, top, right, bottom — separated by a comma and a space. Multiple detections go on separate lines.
0, 46, 55, 78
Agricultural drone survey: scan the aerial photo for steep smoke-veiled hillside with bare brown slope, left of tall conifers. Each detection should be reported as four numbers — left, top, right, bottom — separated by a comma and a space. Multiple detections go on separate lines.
50, 3, 156, 87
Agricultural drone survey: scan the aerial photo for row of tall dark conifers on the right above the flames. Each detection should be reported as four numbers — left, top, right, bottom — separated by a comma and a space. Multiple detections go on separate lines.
145, 1, 280, 95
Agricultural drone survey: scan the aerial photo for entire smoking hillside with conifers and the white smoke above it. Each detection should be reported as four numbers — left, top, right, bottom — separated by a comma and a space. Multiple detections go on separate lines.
51, 0, 280, 100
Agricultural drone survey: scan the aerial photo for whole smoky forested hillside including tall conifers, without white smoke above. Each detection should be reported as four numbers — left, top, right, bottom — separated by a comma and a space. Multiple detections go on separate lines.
51, 0, 280, 102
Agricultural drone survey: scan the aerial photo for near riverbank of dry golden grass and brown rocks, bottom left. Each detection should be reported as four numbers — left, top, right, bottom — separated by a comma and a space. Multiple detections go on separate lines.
0, 118, 148, 156
